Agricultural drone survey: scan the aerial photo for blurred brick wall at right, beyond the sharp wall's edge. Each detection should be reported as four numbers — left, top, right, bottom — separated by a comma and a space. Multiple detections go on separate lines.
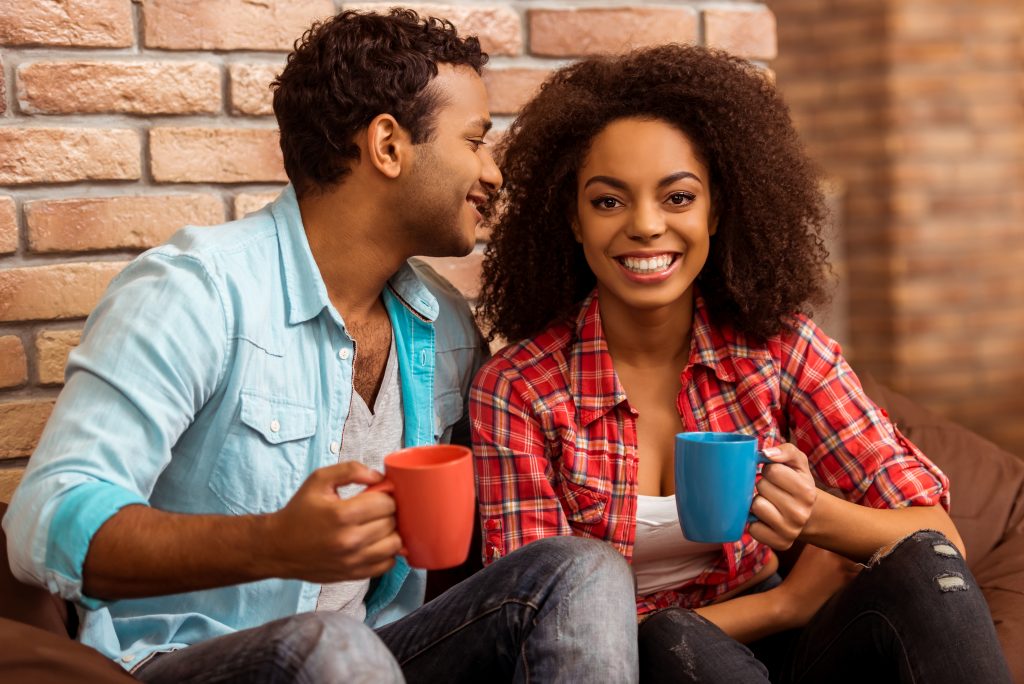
768, 0, 1024, 456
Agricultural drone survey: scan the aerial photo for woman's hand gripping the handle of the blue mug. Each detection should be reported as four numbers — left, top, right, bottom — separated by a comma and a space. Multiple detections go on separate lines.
751, 444, 818, 551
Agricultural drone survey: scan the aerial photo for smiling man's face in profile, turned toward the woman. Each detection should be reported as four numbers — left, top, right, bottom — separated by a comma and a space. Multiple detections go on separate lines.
400, 65, 502, 256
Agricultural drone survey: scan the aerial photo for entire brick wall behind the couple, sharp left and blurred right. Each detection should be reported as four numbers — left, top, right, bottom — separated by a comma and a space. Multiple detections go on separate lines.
0, 0, 1024, 500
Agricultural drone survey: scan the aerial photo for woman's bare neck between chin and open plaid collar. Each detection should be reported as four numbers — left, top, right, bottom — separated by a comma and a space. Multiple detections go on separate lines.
598, 286, 693, 368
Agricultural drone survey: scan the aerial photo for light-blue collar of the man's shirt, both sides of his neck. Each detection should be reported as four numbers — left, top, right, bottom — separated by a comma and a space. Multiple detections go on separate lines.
271, 184, 439, 326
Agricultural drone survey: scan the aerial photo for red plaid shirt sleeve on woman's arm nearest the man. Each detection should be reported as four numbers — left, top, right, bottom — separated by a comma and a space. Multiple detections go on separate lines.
469, 356, 572, 565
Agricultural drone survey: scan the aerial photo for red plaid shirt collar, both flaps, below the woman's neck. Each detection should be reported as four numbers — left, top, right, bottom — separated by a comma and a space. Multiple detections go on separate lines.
569, 289, 771, 425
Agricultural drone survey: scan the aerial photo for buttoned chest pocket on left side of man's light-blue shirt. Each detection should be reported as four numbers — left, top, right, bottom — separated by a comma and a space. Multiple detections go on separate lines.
210, 390, 316, 514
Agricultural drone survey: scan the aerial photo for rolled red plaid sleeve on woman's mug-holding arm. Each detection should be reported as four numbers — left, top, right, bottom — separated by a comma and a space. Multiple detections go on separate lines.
780, 316, 949, 510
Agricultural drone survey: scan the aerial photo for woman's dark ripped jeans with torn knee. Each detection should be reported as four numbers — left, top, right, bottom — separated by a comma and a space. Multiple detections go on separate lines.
639, 530, 1013, 684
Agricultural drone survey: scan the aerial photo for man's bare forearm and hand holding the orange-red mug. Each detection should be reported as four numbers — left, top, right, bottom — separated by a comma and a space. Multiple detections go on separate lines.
83, 462, 401, 600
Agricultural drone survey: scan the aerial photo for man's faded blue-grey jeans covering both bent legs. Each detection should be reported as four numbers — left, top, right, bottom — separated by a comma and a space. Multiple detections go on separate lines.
135, 537, 638, 684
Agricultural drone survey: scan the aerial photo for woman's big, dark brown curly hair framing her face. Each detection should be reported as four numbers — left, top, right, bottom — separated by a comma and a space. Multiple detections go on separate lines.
479, 45, 828, 341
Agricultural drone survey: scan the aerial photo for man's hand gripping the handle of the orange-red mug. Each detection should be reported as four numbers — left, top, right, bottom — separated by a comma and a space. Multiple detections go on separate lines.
267, 461, 401, 584
